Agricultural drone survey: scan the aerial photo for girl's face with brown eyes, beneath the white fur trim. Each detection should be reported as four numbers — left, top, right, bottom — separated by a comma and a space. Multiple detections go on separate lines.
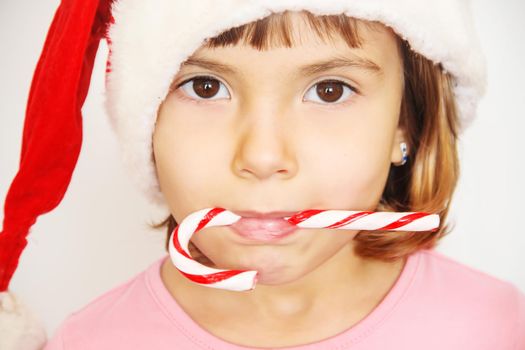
153, 15, 403, 284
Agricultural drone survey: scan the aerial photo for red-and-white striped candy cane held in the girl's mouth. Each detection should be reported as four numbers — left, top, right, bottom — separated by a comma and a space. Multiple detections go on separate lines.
169, 208, 439, 291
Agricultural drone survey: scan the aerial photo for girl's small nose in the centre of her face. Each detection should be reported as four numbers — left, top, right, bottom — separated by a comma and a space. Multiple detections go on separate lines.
232, 106, 297, 180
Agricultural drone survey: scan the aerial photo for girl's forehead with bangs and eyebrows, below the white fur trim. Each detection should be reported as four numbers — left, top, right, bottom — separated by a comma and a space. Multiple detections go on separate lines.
182, 12, 399, 78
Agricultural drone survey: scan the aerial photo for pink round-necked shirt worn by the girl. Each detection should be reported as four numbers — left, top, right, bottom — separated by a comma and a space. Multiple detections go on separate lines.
44, 250, 525, 350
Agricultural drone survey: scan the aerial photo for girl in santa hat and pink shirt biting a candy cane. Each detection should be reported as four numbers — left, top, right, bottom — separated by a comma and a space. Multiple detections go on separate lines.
0, 0, 525, 349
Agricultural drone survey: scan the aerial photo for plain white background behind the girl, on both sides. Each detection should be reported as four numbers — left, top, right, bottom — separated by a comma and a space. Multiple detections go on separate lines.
0, 0, 525, 334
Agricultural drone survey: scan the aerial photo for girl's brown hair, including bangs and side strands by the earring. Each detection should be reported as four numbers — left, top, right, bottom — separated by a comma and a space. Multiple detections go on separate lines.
152, 11, 459, 262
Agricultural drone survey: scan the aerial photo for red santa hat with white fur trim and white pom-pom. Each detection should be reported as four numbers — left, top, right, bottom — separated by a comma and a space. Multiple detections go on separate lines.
0, 0, 486, 350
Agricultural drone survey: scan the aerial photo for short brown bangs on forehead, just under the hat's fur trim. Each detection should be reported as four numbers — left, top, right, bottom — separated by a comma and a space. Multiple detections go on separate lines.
204, 10, 368, 51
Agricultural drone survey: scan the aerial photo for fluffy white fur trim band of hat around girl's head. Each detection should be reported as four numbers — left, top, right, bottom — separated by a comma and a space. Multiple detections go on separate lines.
102, 0, 486, 206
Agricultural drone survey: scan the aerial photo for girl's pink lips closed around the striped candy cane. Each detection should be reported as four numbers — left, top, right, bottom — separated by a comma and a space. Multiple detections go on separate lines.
230, 211, 298, 242
